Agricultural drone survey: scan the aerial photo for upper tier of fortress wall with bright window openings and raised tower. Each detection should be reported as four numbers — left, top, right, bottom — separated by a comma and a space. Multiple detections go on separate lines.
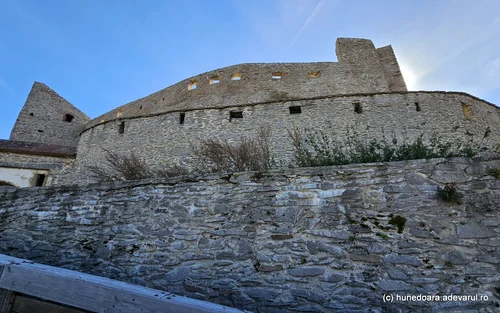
87, 38, 406, 128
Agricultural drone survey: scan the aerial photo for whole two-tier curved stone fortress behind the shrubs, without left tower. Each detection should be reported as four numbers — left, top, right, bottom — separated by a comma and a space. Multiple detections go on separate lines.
68, 38, 500, 183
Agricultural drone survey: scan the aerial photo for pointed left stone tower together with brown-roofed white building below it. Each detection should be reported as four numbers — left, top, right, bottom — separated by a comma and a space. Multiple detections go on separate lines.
0, 82, 90, 187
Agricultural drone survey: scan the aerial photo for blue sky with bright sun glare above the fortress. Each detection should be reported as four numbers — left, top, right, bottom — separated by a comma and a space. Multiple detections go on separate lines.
0, 0, 500, 139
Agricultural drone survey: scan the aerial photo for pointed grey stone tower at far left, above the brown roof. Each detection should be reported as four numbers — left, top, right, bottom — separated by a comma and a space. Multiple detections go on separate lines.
9, 82, 90, 147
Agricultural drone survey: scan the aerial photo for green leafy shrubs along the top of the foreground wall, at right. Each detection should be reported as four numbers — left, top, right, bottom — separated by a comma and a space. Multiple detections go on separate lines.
288, 127, 490, 166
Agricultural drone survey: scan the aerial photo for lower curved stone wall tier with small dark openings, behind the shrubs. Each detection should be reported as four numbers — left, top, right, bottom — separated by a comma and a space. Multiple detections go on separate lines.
72, 92, 500, 182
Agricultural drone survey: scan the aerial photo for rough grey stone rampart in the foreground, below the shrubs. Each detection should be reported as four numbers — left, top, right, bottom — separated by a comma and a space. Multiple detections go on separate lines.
0, 157, 500, 313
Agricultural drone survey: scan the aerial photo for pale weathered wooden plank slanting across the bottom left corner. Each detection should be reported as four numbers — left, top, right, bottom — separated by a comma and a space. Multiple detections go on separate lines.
0, 254, 250, 313
